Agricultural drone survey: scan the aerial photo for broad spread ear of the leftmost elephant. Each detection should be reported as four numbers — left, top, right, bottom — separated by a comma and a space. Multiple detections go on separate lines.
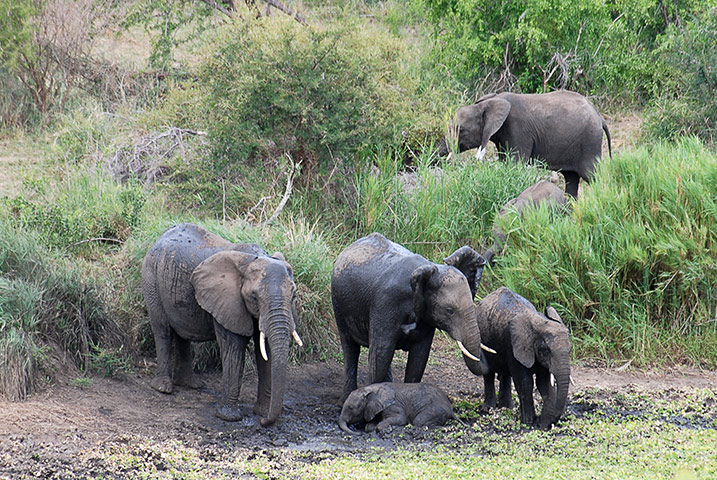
190, 250, 257, 336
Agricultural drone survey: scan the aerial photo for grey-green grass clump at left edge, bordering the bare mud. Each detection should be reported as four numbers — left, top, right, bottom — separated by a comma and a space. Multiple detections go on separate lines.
0, 219, 124, 399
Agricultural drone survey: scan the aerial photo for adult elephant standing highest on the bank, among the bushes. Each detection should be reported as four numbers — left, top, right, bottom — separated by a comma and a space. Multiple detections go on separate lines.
438, 90, 612, 197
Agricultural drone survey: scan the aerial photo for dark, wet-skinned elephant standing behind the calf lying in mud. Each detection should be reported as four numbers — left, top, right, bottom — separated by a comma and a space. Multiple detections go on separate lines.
331, 233, 485, 402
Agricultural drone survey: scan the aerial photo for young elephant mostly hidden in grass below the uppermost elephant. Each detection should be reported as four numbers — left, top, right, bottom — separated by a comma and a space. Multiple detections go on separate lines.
483, 180, 565, 265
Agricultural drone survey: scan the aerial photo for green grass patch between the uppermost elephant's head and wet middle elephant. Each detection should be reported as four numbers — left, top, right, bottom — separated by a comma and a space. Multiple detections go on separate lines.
356, 153, 545, 260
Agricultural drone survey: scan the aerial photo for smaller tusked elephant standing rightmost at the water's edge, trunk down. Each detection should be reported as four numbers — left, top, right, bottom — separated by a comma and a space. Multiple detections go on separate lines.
463, 287, 572, 428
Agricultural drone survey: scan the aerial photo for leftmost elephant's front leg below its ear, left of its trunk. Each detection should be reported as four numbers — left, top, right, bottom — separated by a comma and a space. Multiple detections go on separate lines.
214, 321, 249, 422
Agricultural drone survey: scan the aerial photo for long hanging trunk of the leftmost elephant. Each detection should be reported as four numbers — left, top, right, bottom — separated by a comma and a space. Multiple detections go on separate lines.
260, 312, 292, 427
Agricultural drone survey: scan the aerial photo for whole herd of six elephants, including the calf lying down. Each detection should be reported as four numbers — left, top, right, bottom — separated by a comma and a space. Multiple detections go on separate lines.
142, 92, 610, 433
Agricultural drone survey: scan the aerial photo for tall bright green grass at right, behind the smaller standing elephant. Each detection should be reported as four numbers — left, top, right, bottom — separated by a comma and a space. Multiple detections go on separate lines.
499, 138, 717, 366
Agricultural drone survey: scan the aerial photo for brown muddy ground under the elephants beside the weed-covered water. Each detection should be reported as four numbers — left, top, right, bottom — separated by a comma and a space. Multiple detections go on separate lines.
0, 339, 717, 479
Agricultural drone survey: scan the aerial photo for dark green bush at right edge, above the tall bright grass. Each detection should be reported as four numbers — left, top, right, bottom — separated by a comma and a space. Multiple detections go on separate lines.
645, 7, 717, 145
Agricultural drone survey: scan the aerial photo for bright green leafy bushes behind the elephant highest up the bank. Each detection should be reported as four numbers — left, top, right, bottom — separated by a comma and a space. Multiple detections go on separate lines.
414, 0, 708, 101
